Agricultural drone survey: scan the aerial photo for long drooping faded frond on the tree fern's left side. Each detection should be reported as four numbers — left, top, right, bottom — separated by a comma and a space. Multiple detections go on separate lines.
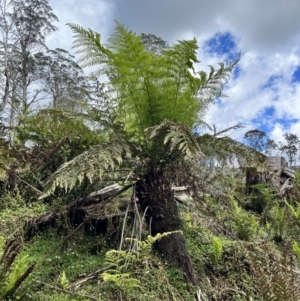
40, 141, 131, 199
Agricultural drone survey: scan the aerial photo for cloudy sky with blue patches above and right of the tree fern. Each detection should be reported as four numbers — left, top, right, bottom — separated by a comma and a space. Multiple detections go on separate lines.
47, 0, 300, 141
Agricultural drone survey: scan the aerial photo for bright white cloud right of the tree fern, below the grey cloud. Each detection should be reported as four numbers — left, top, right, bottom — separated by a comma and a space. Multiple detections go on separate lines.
207, 51, 300, 137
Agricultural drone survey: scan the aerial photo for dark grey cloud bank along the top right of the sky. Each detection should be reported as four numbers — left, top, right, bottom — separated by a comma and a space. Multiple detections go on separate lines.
108, 0, 300, 52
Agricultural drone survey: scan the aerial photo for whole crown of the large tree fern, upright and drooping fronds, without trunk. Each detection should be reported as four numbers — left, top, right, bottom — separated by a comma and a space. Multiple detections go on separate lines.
42, 22, 251, 198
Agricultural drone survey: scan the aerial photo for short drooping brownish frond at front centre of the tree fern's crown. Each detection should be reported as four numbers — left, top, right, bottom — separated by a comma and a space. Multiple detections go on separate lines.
145, 119, 203, 156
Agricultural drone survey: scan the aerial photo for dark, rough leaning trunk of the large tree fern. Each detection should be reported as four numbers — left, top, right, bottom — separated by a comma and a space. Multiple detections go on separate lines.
136, 174, 197, 284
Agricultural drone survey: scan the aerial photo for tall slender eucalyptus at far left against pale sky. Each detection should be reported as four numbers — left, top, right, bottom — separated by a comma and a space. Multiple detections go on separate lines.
0, 0, 58, 123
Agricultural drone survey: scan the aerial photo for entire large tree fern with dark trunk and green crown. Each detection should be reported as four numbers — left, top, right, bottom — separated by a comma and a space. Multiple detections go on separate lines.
42, 22, 260, 283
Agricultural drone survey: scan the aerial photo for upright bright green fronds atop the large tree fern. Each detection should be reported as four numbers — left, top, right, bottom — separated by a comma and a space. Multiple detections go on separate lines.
69, 22, 236, 136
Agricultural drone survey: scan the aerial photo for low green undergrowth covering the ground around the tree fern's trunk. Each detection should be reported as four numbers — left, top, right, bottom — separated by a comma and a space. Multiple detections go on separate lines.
0, 173, 300, 301
